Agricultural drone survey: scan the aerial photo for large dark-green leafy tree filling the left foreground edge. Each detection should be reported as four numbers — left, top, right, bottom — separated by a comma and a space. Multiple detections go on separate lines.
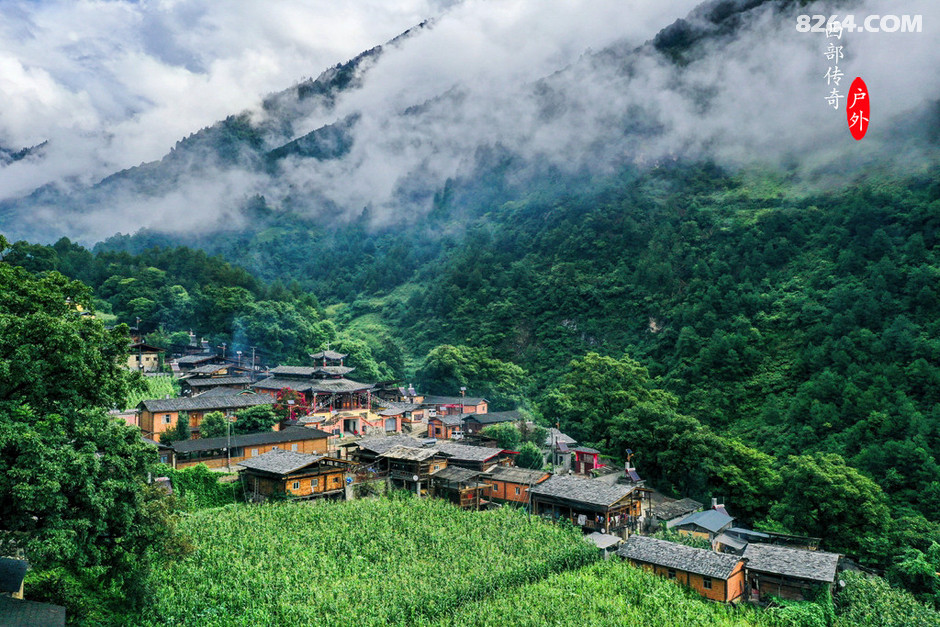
0, 245, 174, 624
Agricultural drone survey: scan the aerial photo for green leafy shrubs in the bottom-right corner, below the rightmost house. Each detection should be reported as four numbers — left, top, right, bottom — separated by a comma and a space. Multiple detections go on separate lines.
835, 572, 940, 627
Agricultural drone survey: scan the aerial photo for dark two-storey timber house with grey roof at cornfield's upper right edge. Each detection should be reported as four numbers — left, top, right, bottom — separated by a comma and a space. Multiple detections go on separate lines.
529, 475, 643, 536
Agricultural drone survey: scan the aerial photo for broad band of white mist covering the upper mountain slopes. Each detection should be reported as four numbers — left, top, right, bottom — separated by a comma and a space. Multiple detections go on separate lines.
0, 0, 940, 242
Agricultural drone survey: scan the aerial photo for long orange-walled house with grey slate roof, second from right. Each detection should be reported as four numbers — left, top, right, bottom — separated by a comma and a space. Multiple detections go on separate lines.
617, 535, 745, 603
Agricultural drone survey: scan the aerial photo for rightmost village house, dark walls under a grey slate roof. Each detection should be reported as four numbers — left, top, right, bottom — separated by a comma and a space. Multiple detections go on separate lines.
743, 542, 840, 601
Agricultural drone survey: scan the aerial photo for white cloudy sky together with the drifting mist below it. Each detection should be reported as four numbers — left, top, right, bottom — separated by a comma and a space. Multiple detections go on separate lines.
0, 0, 940, 240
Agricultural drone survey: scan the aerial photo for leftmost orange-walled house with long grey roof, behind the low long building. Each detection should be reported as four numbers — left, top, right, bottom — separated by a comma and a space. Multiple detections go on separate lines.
137, 394, 271, 440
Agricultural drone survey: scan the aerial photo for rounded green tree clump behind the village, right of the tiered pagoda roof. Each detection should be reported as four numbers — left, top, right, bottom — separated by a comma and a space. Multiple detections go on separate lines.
417, 345, 527, 409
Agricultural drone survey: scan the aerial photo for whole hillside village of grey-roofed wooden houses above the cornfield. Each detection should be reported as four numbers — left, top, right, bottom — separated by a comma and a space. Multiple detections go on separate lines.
117, 342, 854, 603
